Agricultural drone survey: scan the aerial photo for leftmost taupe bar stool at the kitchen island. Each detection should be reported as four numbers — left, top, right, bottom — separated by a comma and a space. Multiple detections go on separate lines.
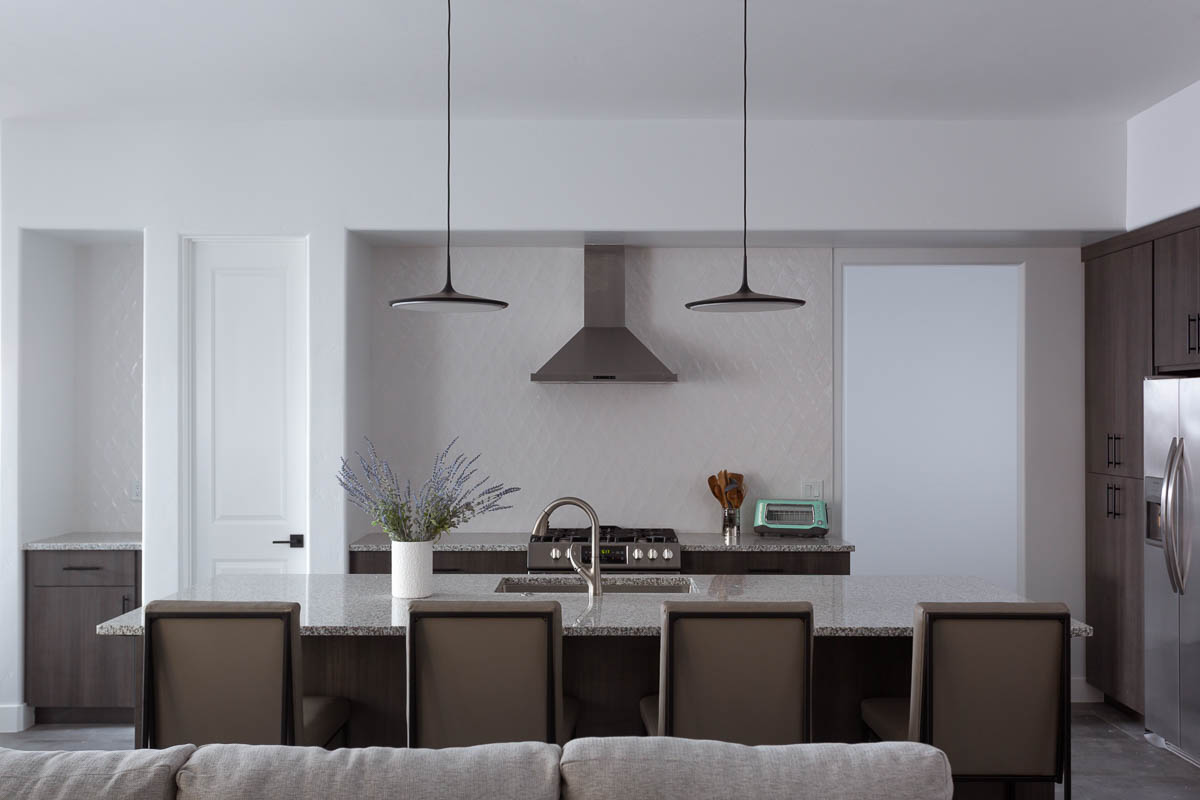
140, 600, 350, 748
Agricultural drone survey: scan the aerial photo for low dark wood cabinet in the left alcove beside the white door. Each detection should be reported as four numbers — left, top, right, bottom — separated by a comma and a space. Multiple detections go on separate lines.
25, 551, 140, 722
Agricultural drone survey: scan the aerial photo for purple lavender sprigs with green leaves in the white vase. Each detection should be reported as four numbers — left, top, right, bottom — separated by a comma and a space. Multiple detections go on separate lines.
337, 437, 521, 542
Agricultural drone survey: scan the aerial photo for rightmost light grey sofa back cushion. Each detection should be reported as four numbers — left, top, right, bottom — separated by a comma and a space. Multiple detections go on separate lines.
560, 736, 954, 800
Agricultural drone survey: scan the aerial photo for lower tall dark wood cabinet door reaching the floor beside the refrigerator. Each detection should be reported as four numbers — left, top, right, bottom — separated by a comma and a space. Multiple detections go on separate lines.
1085, 475, 1146, 712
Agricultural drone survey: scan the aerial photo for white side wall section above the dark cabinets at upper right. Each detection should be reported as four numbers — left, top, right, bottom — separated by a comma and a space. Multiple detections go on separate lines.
1126, 82, 1200, 230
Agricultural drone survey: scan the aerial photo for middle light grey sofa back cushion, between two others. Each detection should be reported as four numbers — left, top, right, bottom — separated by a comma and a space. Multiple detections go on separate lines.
178, 741, 562, 800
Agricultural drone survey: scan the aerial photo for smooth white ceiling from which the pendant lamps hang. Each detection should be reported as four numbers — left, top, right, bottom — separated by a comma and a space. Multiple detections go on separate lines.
0, 0, 1200, 119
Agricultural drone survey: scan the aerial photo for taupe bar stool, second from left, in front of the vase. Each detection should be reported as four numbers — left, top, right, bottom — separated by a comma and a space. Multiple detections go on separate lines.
406, 600, 578, 747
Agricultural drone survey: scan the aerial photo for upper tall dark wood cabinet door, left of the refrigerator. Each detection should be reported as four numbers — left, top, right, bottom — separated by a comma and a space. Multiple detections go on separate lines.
1084, 242, 1154, 477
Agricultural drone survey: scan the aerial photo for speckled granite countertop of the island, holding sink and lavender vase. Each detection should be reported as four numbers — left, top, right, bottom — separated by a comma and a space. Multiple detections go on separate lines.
96, 575, 1092, 637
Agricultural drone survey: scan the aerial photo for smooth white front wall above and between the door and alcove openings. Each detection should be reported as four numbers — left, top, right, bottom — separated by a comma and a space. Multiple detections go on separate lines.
0, 120, 1124, 724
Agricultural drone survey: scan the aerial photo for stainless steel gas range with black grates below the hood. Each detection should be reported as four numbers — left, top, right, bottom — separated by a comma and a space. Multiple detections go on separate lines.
526, 525, 680, 573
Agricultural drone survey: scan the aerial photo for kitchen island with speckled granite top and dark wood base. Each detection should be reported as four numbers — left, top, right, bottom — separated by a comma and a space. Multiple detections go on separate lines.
96, 573, 1091, 746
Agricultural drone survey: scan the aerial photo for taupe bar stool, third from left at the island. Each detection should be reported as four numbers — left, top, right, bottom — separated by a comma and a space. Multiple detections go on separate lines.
641, 602, 812, 745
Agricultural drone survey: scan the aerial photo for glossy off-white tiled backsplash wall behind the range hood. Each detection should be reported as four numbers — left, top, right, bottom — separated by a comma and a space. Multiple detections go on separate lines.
352, 247, 833, 536
